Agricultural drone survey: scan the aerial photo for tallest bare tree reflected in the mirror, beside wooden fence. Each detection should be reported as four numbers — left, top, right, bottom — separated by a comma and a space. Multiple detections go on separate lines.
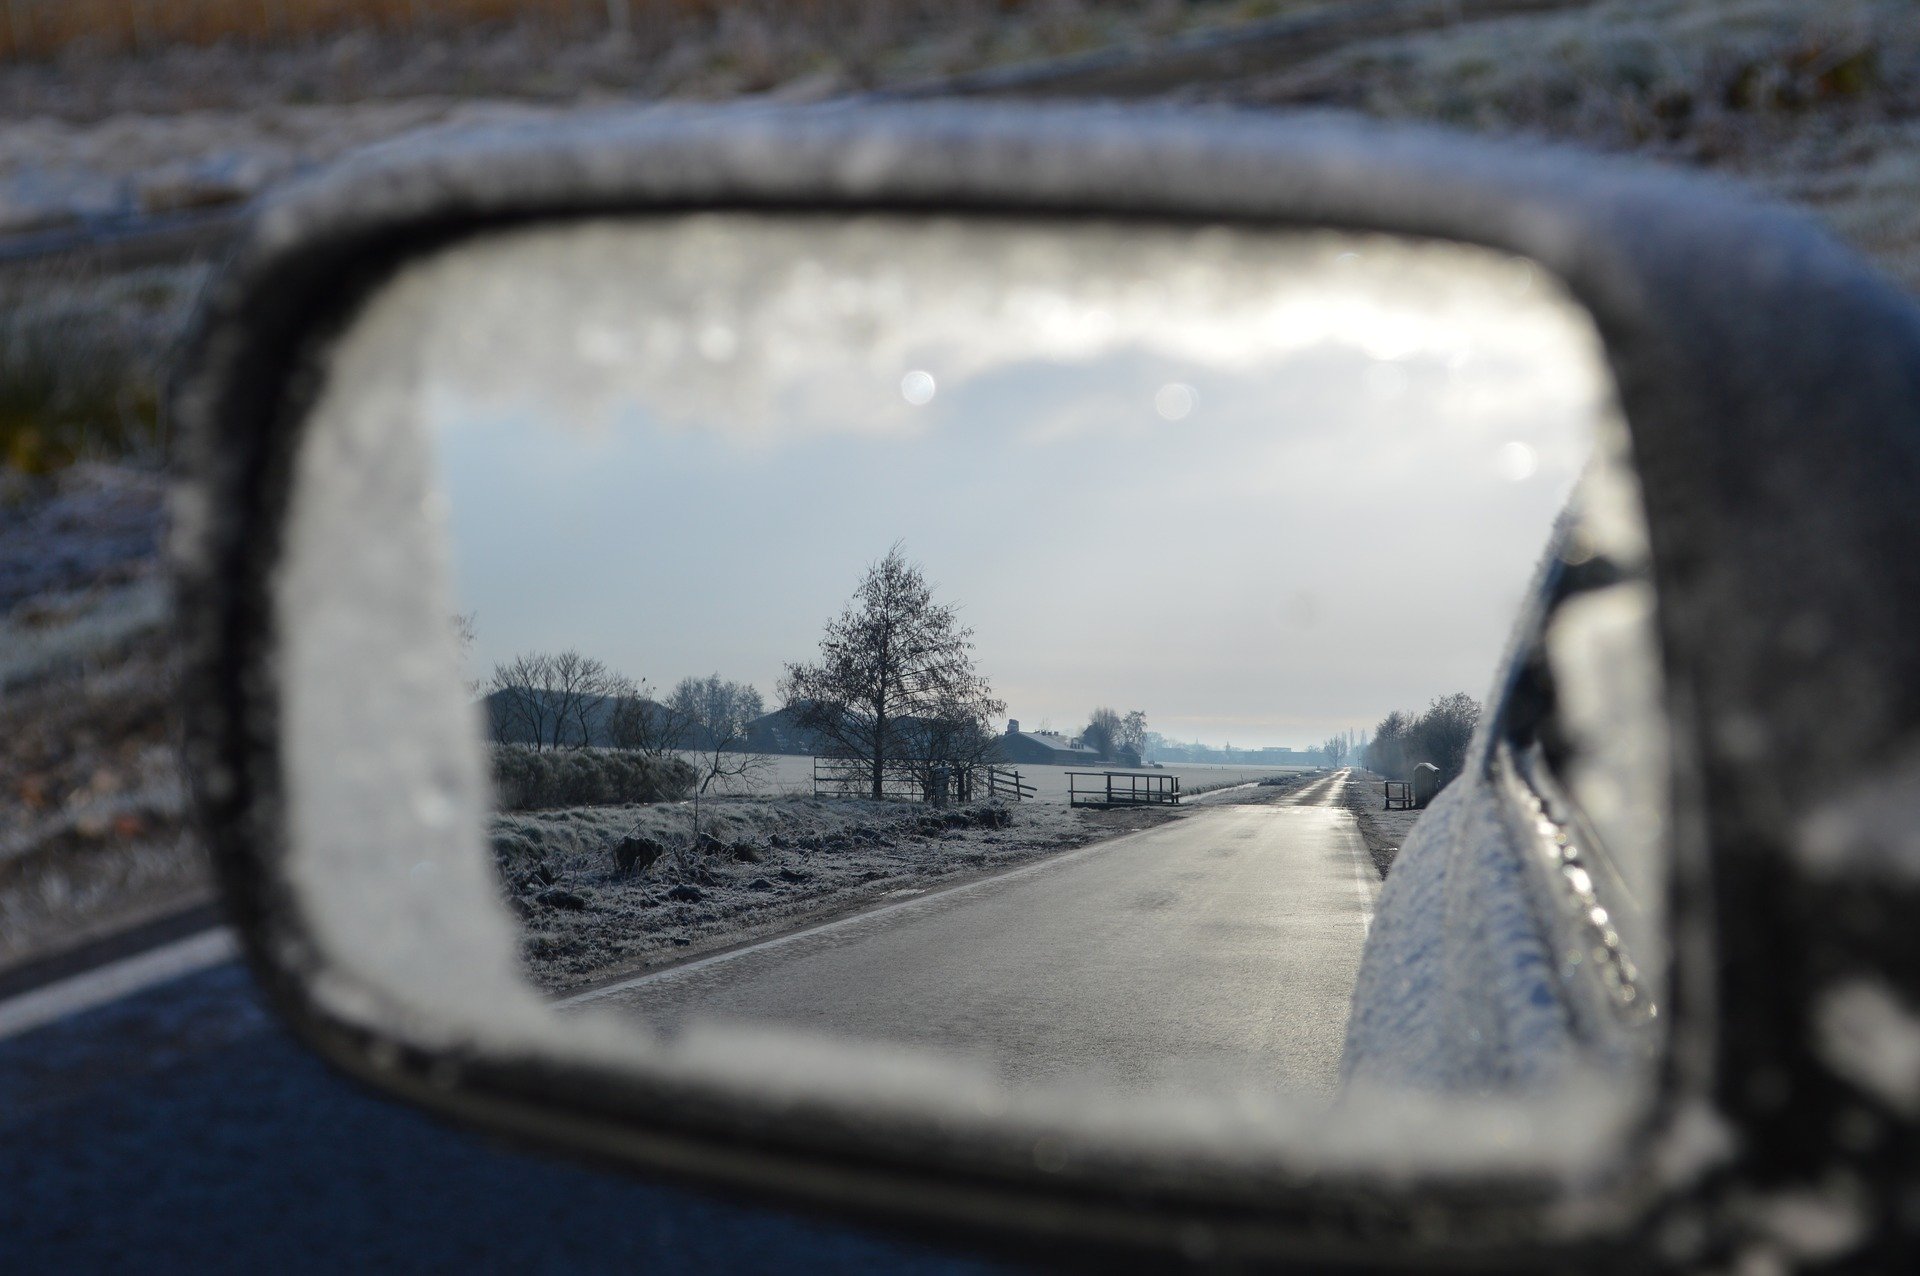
780, 545, 1006, 798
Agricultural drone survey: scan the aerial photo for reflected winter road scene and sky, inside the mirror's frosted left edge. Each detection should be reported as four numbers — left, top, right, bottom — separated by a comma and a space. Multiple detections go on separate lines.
284, 213, 1665, 1128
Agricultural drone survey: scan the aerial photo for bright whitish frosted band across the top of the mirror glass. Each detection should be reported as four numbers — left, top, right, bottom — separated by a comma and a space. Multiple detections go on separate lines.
394, 213, 1596, 458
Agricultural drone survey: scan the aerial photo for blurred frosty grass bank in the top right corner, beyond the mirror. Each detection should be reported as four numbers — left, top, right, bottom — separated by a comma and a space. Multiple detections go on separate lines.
1236, 0, 1920, 288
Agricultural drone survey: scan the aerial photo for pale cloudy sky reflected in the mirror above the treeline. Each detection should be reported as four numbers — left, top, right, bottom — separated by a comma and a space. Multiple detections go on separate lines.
386, 217, 1607, 746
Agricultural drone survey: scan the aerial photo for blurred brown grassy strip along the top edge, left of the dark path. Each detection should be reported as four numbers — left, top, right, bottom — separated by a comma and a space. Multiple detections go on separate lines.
0, 0, 1325, 106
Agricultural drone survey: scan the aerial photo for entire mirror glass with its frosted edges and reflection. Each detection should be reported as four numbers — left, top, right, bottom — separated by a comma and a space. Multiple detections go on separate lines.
276, 213, 1663, 1143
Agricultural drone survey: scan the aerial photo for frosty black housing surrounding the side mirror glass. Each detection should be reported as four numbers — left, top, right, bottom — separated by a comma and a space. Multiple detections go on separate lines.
175, 106, 1920, 1266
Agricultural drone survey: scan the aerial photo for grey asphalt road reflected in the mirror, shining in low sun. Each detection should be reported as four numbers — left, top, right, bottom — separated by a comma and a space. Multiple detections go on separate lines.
572, 773, 1379, 1092
